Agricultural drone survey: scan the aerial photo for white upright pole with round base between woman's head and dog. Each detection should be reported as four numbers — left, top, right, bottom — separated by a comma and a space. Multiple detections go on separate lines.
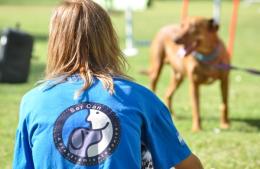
123, 4, 138, 56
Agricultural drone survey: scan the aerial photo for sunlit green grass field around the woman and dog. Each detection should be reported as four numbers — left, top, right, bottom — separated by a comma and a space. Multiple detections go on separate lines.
0, 0, 260, 169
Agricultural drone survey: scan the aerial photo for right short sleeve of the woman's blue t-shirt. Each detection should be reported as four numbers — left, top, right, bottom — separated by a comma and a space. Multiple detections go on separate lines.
143, 102, 191, 169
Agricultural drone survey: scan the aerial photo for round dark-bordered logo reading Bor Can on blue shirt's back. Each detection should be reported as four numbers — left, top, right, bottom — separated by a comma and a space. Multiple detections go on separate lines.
53, 103, 120, 166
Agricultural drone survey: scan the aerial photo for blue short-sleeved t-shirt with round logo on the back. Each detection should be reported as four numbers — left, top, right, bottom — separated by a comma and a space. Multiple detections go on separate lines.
13, 76, 191, 169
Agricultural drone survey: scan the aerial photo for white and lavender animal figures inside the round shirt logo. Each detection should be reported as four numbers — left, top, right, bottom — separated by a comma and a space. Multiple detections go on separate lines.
68, 109, 113, 157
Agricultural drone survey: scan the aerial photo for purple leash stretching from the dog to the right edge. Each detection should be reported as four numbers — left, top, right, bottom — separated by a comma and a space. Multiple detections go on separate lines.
214, 64, 260, 76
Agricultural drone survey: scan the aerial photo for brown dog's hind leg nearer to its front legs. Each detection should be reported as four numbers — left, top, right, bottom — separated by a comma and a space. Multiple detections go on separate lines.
164, 72, 183, 116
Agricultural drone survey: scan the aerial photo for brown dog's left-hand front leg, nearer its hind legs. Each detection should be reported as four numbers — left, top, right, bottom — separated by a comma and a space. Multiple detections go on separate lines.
189, 75, 201, 132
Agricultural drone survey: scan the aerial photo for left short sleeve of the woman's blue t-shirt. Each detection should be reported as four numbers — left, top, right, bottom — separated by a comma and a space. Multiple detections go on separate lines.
13, 97, 34, 169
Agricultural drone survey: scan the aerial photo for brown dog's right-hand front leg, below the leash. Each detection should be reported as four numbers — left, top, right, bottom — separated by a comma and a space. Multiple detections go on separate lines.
220, 74, 229, 129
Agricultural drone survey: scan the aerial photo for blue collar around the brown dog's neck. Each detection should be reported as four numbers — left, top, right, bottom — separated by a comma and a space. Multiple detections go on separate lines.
192, 45, 220, 62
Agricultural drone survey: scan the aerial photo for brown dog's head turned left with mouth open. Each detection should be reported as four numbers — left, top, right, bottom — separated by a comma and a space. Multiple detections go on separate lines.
173, 17, 219, 56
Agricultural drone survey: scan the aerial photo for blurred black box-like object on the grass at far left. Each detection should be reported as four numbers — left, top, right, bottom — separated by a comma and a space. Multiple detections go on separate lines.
0, 29, 33, 83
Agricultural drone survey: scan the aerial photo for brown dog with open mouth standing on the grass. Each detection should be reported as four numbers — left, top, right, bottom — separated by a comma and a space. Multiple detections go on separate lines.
148, 17, 230, 131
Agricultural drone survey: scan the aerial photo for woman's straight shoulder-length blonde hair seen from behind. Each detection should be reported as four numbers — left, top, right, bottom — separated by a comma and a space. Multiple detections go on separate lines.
45, 0, 129, 93
